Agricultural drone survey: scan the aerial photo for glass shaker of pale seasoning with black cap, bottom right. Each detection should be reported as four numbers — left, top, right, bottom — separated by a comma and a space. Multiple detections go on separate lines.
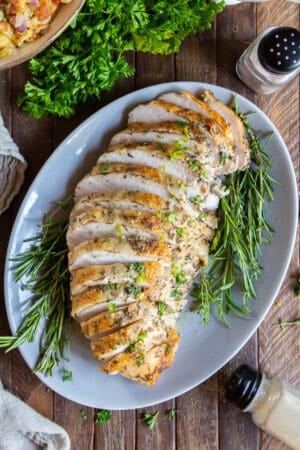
225, 364, 300, 450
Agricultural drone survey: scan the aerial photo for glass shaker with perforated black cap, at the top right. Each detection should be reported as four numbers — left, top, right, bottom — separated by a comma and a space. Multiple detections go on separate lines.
236, 27, 300, 94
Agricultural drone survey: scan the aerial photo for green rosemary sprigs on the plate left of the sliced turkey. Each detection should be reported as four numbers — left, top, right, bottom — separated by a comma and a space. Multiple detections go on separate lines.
0, 202, 71, 378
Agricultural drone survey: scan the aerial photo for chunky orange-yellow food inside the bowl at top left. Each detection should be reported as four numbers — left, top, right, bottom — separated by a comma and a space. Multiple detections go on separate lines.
0, 0, 71, 57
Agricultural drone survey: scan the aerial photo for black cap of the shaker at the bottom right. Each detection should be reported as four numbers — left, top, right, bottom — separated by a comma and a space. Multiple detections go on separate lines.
225, 364, 262, 409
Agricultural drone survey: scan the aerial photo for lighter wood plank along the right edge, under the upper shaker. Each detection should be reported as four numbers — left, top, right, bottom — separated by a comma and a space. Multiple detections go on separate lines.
257, 0, 300, 450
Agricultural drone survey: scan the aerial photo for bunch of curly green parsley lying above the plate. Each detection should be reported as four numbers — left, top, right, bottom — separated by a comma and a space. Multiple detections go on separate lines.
18, 0, 224, 119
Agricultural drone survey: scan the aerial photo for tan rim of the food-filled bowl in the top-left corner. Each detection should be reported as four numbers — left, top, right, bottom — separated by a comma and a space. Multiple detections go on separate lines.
0, 0, 85, 70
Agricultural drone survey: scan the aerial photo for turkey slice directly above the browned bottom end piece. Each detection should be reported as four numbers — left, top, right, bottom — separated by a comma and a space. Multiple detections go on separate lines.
90, 317, 176, 360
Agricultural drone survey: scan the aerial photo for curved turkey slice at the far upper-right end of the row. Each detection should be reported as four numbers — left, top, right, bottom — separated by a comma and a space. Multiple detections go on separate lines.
202, 91, 250, 170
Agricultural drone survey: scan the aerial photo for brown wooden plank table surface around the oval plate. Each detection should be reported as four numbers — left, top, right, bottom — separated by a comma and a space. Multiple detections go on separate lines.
0, 0, 300, 450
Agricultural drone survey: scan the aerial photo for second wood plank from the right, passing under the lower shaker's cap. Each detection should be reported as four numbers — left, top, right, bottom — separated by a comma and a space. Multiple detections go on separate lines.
217, 3, 259, 450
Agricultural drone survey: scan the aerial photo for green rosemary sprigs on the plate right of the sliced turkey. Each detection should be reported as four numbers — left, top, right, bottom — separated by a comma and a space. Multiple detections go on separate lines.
191, 102, 276, 324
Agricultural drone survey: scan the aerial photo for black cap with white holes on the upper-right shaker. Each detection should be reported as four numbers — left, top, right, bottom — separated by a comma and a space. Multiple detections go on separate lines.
258, 27, 300, 74
